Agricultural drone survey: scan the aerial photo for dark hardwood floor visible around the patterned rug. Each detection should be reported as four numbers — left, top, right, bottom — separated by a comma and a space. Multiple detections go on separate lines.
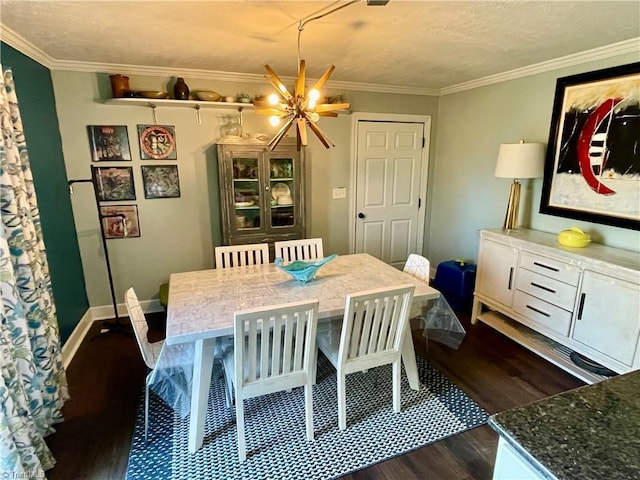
47, 314, 583, 480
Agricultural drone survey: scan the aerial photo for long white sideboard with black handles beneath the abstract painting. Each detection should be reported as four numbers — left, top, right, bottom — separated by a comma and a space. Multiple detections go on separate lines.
471, 229, 640, 383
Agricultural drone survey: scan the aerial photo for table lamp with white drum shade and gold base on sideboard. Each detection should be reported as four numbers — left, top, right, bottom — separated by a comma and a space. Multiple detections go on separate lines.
495, 141, 545, 230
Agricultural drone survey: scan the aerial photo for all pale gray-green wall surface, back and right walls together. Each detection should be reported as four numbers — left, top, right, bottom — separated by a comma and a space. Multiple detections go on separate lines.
12, 48, 640, 334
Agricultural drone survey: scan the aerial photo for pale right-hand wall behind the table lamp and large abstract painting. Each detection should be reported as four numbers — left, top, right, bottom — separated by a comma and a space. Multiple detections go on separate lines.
428, 54, 640, 265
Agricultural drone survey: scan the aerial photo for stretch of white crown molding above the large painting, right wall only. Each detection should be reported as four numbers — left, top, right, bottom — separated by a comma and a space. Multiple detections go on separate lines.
439, 37, 640, 95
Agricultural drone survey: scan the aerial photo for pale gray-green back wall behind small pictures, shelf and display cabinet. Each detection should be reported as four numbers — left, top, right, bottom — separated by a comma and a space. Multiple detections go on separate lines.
52, 71, 438, 306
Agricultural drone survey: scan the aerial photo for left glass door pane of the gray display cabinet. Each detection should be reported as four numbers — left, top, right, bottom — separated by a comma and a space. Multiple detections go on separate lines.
231, 157, 263, 230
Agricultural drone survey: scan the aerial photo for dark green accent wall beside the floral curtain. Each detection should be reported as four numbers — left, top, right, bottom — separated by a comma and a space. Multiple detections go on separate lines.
0, 43, 89, 343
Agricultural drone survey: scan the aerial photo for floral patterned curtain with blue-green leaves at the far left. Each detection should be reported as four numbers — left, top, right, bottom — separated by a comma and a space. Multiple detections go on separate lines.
0, 65, 69, 479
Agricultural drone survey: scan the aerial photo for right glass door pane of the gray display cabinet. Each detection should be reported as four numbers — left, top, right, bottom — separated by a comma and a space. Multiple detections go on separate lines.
269, 157, 298, 229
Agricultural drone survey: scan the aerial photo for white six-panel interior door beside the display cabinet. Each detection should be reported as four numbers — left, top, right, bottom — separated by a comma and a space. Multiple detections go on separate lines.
355, 121, 426, 268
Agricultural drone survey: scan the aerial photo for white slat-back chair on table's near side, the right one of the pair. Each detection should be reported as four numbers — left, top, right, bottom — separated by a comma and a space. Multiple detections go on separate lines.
316, 285, 415, 430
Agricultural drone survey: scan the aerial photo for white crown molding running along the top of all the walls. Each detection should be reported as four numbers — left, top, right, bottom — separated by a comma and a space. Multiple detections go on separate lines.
0, 23, 640, 96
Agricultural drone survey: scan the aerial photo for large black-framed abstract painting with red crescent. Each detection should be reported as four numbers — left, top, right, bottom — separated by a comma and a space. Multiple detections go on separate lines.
540, 62, 640, 230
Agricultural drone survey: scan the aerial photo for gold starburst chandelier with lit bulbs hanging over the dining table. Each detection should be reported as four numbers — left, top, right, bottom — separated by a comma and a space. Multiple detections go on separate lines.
255, 0, 372, 150
